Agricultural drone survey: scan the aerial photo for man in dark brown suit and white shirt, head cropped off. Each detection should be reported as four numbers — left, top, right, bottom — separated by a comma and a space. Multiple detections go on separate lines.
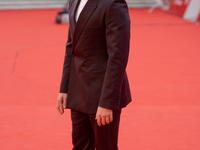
56, 0, 131, 150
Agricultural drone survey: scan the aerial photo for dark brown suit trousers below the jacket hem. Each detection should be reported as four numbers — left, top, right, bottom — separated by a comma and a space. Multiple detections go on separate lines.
71, 110, 121, 150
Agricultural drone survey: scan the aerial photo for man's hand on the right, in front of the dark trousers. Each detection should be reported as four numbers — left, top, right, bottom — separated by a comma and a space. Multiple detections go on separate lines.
95, 106, 113, 126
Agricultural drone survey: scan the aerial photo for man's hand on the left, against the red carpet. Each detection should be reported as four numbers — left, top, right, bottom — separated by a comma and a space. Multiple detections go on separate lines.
56, 93, 67, 115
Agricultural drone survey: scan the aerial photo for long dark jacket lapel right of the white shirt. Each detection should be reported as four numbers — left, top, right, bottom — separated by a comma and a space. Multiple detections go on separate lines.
72, 0, 99, 50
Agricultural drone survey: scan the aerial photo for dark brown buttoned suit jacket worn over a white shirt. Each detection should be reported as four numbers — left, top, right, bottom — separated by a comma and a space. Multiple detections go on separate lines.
60, 0, 131, 114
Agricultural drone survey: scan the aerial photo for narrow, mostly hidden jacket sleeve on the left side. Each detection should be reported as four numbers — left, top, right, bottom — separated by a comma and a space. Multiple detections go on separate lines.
60, 30, 72, 93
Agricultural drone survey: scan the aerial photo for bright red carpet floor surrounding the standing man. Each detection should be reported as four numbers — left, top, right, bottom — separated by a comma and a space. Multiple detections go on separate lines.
0, 9, 200, 150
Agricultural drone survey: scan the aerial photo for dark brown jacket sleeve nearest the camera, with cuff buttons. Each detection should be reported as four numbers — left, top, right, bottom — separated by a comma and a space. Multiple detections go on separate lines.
99, 0, 130, 109
